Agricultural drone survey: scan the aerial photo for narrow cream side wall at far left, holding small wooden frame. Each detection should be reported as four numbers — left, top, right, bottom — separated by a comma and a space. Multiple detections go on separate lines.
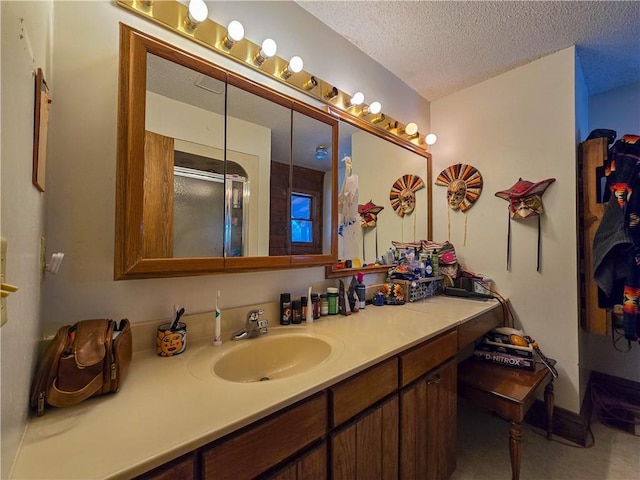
0, 2, 56, 478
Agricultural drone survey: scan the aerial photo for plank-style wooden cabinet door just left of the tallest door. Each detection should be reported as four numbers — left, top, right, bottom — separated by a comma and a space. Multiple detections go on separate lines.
331, 395, 399, 480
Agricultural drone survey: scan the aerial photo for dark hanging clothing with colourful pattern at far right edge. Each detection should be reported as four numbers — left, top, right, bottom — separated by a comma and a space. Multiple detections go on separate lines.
593, 135, 640, 341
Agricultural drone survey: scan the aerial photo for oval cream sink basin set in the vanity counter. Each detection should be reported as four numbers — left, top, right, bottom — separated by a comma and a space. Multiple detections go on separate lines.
189, 332, 342, 383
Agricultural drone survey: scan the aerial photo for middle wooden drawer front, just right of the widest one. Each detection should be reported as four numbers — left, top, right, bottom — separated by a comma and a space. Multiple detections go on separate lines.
329, 357, 398, 427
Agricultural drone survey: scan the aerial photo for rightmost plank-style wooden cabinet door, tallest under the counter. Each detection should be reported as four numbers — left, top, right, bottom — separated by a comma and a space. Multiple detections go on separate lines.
400, 358, 457, 480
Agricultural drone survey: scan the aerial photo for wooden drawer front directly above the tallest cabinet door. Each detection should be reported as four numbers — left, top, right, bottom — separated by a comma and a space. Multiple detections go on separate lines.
400, 330, 458, 387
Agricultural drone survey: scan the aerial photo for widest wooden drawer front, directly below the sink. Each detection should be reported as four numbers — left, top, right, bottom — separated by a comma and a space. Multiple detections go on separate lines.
202, 393, 327, 480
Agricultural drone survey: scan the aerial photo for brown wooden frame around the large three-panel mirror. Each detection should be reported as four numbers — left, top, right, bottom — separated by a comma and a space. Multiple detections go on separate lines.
114, 23, 338, 280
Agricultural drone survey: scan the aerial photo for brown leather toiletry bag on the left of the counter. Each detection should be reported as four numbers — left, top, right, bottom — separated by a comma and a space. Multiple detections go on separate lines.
30, 319, 132, 415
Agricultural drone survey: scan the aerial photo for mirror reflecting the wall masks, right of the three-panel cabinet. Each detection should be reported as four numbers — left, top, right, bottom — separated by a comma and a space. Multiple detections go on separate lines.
327, 115, 432, 277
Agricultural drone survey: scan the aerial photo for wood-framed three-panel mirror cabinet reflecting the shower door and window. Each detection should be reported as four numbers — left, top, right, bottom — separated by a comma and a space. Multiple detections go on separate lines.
114, 25, 338, 279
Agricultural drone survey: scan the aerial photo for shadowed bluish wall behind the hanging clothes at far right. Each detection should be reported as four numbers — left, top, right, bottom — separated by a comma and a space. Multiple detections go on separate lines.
580, 82, 640, 382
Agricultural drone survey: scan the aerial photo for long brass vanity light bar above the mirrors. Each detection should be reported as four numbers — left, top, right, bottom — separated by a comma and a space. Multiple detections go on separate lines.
117, 0, 427, 149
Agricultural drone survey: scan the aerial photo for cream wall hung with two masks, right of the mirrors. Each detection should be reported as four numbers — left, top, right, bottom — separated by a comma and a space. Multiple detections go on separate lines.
431, 48, 580, 412
